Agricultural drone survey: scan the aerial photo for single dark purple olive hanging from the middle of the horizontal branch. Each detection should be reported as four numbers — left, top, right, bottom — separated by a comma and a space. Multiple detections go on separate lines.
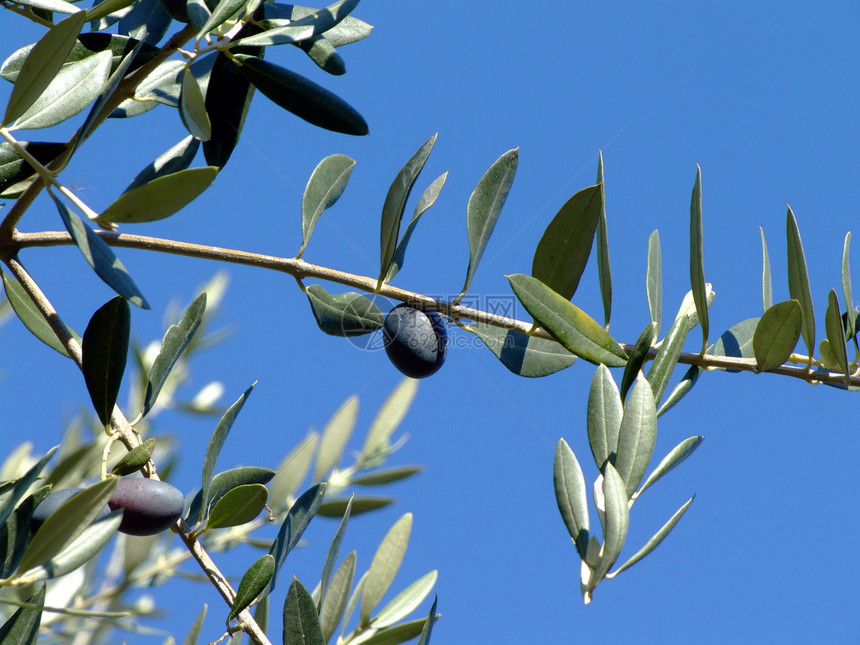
382, 303, 448, 378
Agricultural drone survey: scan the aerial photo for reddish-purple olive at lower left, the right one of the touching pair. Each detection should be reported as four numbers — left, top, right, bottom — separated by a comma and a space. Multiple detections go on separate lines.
108, 477, 185, 535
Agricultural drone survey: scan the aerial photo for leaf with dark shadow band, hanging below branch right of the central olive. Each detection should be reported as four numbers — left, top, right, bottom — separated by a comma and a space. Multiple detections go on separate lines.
467, 323, 576, 378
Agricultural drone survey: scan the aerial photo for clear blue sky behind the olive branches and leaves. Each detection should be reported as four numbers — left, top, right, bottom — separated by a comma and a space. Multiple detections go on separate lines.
0, 1, 860, 643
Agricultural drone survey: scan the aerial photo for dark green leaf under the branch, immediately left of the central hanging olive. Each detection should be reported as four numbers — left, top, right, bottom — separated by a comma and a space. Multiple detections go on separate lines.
305, 284, 385, 336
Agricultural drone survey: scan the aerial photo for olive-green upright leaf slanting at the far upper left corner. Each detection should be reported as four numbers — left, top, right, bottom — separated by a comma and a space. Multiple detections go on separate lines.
2, 11, 87, 126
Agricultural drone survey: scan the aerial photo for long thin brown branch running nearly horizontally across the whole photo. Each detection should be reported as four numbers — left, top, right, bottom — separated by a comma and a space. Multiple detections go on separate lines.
9, 226, 860, 387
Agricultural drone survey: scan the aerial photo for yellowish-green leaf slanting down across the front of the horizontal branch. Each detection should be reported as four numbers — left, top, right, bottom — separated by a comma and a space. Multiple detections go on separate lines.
507, 274, 627, 367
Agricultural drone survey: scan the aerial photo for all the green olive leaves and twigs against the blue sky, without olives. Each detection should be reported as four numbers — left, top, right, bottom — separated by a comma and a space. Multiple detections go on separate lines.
0, 0, 860, 643
